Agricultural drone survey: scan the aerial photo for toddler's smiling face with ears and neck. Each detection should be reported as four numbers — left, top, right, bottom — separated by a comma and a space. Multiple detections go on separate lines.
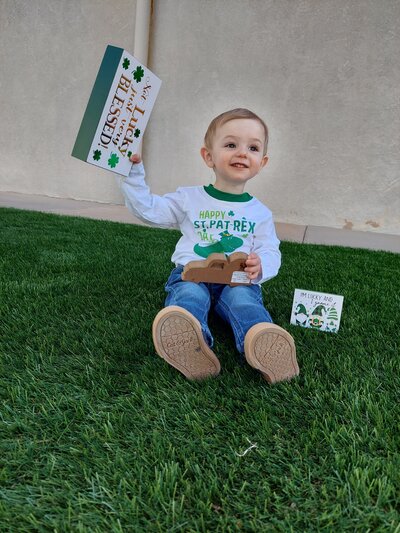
201, 118, 268, 194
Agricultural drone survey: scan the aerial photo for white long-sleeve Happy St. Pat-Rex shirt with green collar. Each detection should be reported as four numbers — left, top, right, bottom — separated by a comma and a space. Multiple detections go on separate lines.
121, 163, 281, 283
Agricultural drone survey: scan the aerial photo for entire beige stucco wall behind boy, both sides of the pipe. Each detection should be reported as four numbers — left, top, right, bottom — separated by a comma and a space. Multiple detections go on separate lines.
0, 0, 400, 234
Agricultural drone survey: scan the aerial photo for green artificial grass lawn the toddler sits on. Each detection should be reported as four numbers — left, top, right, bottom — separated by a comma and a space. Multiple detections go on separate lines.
0, 209, 400, 532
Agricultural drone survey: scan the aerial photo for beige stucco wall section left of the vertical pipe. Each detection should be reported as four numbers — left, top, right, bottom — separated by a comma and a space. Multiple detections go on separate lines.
0, 0, 136, 203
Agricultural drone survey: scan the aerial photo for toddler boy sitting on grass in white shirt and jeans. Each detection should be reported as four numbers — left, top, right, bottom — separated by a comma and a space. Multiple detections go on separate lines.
121, 109, 299, 383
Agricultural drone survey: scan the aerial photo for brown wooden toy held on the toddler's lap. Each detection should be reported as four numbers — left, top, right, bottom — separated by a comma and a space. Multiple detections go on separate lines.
182, 252, 250, 287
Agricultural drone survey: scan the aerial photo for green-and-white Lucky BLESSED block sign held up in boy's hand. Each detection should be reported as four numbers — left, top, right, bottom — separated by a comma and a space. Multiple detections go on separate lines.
72, 46, 161, 176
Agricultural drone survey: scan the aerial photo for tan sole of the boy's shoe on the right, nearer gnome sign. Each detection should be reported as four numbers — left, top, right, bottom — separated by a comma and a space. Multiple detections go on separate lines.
244, 322, 300, 383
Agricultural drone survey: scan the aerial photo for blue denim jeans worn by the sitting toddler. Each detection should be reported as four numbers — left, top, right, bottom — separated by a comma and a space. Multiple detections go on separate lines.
165, 265, 272, 353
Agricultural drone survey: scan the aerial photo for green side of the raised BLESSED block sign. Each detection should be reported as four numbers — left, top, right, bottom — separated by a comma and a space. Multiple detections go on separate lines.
72, 45, 124, 161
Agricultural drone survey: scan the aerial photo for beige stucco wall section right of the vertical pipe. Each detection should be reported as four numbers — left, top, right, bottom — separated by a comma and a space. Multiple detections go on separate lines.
145, 0, 400, 234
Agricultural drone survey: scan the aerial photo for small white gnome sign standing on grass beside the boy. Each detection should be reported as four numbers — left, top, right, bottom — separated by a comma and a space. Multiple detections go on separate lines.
290, 289, 343, 333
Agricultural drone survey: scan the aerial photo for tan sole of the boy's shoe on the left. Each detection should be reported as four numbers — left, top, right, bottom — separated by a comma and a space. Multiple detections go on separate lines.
153, 305, 221, 380
